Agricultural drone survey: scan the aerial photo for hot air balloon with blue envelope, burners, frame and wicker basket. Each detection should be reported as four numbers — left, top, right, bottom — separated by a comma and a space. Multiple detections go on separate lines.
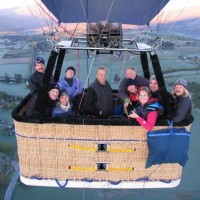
12, 0, 192, 189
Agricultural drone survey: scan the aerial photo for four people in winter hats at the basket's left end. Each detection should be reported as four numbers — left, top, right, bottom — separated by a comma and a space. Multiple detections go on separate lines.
24, 57, 83, 117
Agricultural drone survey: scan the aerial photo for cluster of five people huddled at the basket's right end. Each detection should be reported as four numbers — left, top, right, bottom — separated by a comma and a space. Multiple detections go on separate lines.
119, 67, 193, 130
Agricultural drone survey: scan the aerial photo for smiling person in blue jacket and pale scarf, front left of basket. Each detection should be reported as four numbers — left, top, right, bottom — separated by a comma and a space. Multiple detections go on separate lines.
51, 89, 73, 117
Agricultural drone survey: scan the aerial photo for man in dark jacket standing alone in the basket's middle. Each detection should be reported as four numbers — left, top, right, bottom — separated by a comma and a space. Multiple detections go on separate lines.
83, 67, 114, 118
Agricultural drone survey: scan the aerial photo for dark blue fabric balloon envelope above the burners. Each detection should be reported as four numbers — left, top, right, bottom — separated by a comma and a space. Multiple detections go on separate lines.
41, 0, 169, 25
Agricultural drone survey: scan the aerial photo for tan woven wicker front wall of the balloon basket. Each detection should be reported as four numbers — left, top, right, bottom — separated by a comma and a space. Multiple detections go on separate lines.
14, 121, 182, 181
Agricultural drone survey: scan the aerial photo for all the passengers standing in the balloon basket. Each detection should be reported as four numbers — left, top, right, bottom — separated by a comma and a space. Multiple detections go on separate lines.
25, 57, 193, 130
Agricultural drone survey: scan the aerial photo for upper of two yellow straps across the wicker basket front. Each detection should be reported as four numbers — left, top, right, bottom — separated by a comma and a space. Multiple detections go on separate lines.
69, 145, 136, 153
